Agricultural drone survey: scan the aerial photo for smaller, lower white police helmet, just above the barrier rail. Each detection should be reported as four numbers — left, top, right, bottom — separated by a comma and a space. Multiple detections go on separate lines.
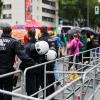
45, 49, 57, 60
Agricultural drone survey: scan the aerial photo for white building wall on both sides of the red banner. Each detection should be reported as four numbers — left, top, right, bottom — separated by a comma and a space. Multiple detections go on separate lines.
0, 0, 56, 27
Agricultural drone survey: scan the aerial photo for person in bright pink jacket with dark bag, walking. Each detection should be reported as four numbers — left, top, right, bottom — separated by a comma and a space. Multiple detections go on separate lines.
67, 33, 83, 69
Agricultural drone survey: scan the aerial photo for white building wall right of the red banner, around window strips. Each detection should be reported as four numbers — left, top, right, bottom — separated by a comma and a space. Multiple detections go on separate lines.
32, 0, 56, 27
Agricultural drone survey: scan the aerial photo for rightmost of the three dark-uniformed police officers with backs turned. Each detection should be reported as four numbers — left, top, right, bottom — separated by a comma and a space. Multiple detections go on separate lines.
39, 26, 56, 100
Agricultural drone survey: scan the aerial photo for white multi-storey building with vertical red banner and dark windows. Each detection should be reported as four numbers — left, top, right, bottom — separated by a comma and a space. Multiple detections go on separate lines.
0, 0, 58, 27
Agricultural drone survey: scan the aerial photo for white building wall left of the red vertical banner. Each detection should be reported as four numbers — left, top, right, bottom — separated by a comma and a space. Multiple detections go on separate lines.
0, 0, 25, 25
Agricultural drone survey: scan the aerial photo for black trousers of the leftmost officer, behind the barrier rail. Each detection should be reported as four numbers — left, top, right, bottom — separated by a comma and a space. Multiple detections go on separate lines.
0, 76, 13, 100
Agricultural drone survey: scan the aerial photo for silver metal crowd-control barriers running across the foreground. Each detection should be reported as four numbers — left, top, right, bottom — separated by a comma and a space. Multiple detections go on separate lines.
0, 47, 100, 100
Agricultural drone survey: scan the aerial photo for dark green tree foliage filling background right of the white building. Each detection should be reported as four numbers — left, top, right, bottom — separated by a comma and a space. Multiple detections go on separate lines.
59, 0, 100, 26
